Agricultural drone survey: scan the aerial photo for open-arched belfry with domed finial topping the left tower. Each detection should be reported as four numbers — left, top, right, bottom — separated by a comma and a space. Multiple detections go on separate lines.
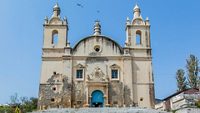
43, 4, 68, 48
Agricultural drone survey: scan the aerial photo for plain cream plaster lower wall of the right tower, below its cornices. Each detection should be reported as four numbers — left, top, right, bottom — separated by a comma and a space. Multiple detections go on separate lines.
133, 61, 153, 107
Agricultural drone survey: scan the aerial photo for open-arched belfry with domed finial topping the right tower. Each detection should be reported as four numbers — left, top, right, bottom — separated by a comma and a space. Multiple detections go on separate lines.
125, 5, 150, 48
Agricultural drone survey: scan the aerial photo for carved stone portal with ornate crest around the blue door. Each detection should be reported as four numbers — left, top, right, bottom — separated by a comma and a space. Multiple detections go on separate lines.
87, 67, 109, 107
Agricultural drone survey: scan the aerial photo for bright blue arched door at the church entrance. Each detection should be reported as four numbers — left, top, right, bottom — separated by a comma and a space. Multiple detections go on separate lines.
91, 90, 104, 107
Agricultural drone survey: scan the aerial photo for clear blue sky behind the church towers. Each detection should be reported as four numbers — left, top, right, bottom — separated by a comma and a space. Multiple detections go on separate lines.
0, 0, 200, 103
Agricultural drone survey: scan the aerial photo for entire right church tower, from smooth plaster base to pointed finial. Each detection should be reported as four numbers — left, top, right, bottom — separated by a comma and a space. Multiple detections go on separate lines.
124, 4, 154, 108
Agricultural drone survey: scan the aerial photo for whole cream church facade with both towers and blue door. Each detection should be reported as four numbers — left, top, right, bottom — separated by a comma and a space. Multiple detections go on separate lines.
38, 4, 154, 109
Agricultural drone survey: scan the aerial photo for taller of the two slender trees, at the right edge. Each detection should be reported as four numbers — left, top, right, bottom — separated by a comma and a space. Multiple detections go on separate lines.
186, 55, 199, 88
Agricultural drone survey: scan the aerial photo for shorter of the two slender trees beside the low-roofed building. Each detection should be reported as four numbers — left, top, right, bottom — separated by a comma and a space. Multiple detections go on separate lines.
176, 69, 187, 91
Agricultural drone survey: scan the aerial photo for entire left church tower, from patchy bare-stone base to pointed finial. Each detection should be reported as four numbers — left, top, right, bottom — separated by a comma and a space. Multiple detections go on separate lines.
38, 4, 71, 110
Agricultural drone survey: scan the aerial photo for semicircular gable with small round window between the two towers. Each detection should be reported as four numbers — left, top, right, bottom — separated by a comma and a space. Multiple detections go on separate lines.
73, 35, 123, 56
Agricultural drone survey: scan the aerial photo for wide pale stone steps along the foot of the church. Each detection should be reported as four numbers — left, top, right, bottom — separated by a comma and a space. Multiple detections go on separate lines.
32, 107, 169, 113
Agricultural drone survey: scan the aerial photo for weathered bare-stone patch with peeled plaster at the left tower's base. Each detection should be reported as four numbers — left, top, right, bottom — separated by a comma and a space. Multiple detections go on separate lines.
38, 74, 71, 109
